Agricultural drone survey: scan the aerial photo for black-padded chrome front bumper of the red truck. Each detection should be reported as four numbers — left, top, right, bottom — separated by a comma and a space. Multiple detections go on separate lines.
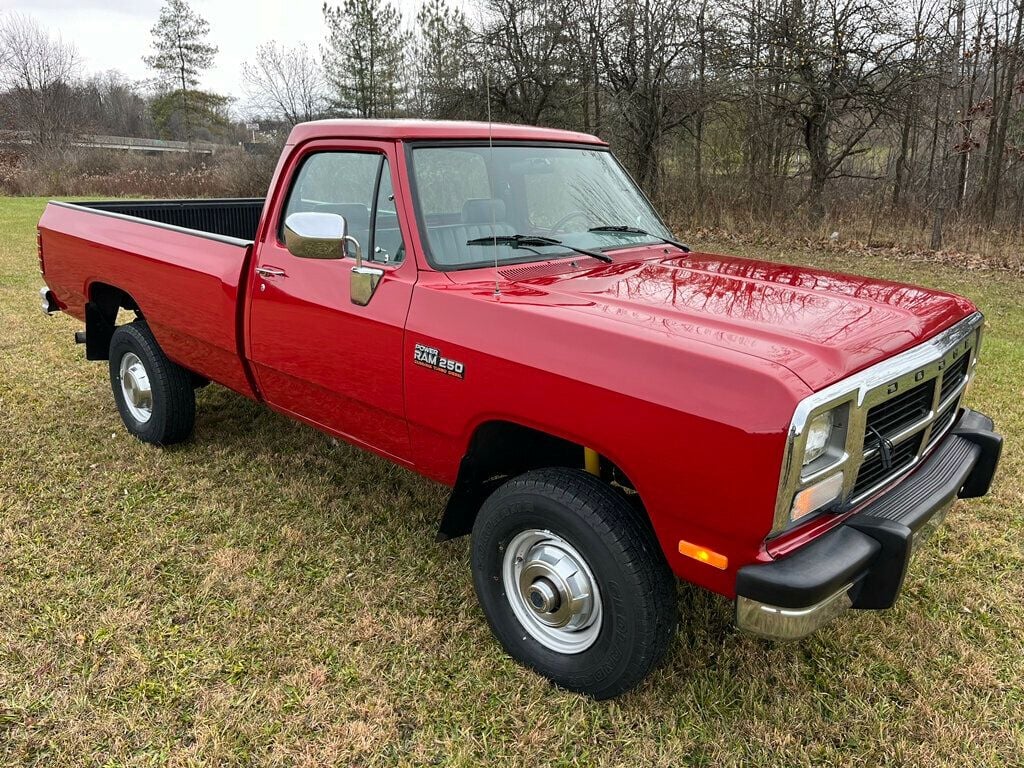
736, 410, 1002, 640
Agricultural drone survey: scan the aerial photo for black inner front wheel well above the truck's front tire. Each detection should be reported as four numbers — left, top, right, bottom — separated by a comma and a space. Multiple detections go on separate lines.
437, 421, 634, 541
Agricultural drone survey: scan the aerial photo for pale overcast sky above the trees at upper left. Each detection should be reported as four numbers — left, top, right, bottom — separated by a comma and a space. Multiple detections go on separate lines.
0, 0, 446, 102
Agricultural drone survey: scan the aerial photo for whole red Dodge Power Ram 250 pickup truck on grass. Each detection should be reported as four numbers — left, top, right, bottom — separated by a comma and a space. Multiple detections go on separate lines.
39, 121, 1001, 697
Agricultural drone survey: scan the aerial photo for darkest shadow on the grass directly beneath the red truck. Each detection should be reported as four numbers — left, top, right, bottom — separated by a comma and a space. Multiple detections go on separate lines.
186, 386, 770, 665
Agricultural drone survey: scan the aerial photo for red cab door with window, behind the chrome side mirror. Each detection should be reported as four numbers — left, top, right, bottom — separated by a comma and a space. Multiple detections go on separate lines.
246, 141, 416, 461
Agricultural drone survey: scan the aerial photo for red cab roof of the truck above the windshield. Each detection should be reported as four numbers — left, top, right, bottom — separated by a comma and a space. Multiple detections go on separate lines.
288, 120, 607, 146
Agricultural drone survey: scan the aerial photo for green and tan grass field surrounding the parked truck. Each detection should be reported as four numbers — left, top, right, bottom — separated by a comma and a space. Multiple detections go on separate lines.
0, 199, 1024, 766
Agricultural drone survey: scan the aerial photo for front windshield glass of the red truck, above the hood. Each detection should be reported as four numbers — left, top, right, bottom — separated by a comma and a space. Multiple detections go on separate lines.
413, 144, 672, 269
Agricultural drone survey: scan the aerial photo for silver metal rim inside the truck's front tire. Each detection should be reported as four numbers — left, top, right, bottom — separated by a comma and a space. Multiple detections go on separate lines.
502, 528, 601, 653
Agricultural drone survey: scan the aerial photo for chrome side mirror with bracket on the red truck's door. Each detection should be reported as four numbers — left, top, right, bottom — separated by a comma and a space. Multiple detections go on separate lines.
285, 211, 384, 306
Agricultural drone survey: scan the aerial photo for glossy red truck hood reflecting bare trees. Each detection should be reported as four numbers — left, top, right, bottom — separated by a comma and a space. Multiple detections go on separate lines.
487, 247, 975, 390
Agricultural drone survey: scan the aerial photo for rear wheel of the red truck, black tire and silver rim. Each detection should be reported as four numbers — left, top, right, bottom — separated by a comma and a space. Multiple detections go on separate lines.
110, 321, 196, 445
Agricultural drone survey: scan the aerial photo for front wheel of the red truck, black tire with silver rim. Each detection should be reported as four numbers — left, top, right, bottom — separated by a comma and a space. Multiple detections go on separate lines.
472, 469, 677, 698
